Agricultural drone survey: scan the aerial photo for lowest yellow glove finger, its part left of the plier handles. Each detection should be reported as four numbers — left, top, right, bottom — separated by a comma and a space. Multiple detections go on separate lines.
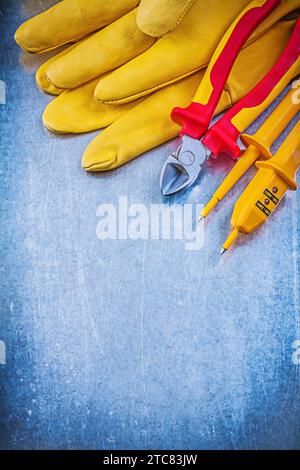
82, 70, 230, 172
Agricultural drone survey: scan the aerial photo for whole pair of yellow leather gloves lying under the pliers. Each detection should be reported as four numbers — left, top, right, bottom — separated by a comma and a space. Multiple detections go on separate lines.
15, 0, 300, 171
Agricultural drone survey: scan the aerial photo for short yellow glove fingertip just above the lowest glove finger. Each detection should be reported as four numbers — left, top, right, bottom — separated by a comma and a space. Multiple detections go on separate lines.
43, 79, 142, 134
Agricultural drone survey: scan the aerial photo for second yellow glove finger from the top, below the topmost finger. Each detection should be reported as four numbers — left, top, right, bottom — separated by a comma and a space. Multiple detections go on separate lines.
37, 9, 155, 92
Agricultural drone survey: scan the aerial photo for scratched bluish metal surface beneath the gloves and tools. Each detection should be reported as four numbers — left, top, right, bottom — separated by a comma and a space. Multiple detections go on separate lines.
0, 0, 300, 449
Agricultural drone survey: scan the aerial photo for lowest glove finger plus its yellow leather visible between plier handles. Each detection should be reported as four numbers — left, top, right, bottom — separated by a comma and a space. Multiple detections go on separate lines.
82, 21, 295, 171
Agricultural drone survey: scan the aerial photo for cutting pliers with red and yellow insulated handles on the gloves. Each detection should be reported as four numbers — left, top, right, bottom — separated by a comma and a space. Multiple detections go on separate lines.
160, 0, 300, 196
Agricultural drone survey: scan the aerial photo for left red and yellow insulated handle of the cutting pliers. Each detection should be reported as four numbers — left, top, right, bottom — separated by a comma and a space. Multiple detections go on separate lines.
171, 0, 281, 139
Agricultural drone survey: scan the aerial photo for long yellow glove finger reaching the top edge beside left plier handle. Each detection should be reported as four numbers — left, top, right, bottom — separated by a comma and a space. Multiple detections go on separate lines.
95, 0, 300, 104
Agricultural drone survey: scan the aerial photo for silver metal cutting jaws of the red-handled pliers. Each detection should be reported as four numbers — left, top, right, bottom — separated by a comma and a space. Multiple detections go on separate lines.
160, 135, 210, 196
